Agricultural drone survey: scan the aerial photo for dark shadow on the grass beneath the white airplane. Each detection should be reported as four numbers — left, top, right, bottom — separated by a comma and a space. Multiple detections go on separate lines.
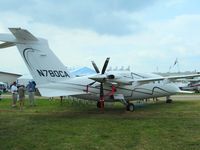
20, 102, 172, 119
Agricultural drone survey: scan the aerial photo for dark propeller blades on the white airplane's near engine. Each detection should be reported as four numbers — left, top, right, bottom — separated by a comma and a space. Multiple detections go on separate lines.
92, 57, 110, 110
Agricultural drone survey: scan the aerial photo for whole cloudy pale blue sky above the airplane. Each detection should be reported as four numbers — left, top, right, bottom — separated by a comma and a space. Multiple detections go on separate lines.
0, 0, 200, 73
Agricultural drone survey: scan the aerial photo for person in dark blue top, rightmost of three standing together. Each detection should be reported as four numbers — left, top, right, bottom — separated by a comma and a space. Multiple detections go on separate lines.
27, 81, 36, 106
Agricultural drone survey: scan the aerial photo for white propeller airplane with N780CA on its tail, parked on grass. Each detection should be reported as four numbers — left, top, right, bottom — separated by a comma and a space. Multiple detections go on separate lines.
0, 28, 200, 111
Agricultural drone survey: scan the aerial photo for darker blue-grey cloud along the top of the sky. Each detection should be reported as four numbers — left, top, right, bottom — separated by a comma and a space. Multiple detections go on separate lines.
0, 0, 155, 35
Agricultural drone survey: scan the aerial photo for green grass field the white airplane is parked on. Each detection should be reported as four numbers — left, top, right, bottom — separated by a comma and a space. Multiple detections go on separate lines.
0, 95, 200, 150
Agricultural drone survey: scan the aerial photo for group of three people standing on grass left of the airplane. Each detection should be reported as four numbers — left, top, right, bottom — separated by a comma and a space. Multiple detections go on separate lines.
10, 81, 36, 110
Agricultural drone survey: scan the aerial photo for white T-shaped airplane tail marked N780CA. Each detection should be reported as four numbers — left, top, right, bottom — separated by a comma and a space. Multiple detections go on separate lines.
0, 28, 70, 84
